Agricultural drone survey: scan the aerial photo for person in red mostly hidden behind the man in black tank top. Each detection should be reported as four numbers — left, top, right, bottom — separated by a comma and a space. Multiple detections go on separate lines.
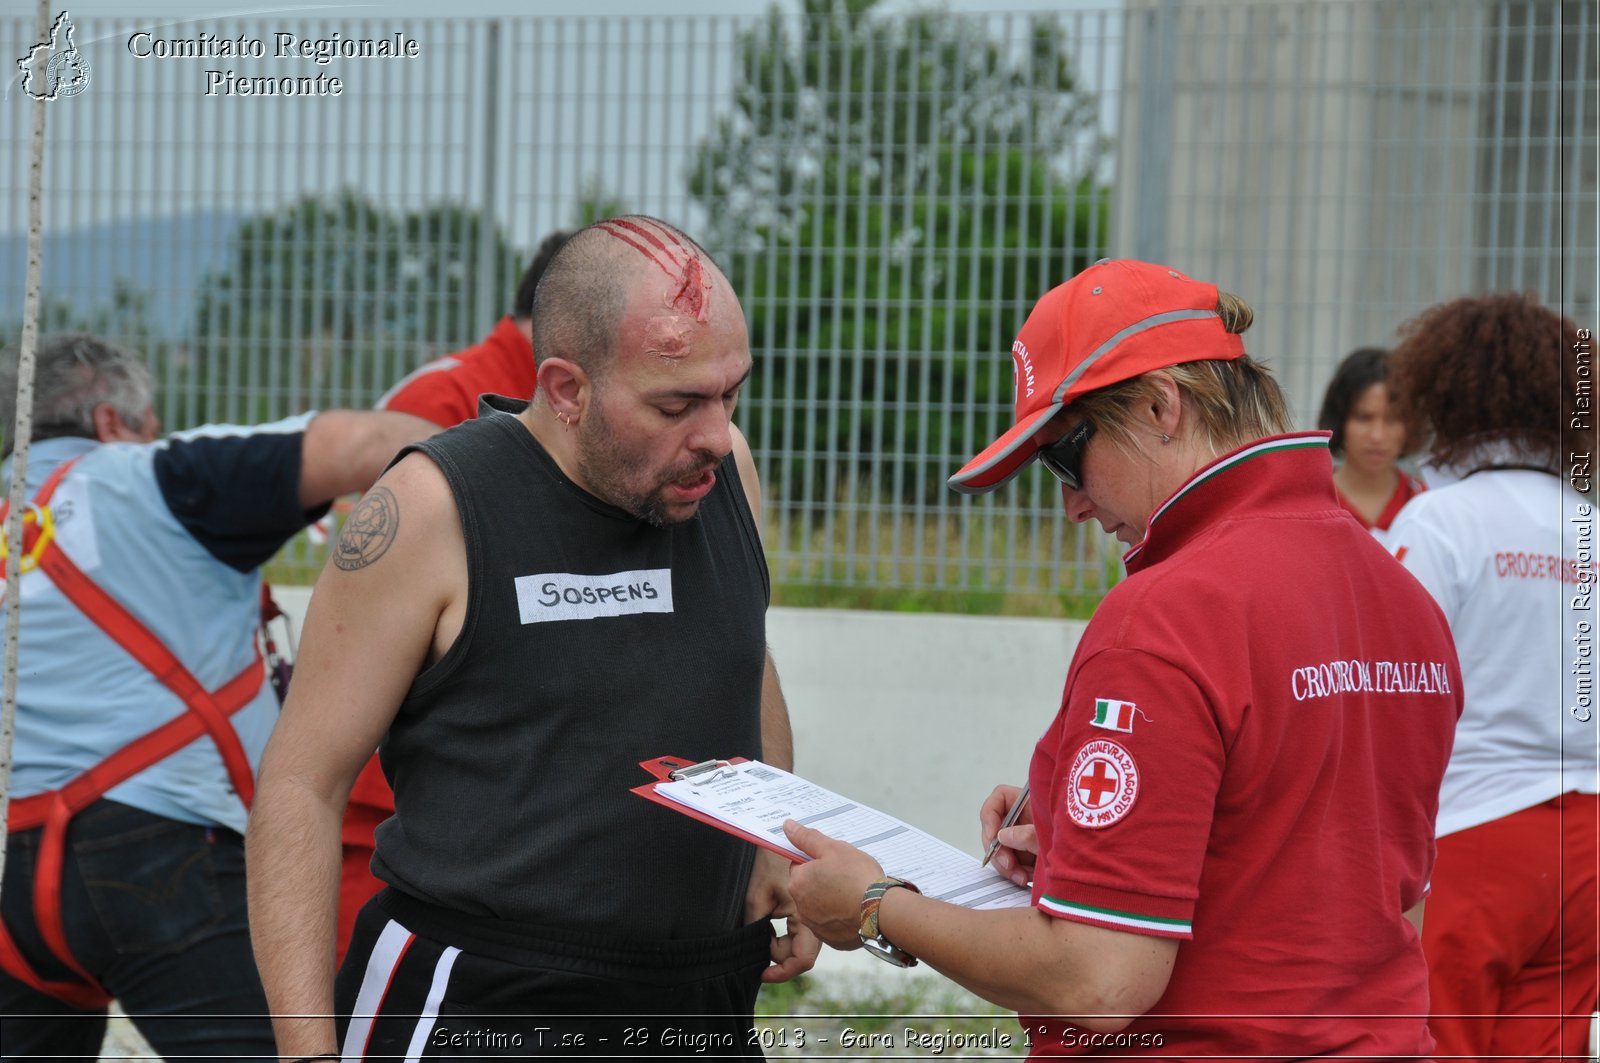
338, 231, 573, 962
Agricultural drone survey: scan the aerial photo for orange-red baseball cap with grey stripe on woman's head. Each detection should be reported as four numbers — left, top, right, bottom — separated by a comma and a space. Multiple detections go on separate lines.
949, 259, 1245, 495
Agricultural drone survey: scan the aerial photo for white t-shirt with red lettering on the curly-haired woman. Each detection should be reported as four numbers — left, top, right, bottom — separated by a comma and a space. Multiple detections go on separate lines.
1387, 469, 1600, 837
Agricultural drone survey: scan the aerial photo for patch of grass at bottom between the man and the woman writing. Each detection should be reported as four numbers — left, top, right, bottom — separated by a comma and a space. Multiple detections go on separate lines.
755, 975, 1026, 1058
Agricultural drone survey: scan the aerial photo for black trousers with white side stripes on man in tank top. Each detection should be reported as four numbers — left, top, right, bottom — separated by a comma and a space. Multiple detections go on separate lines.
334, 889, 773, 1063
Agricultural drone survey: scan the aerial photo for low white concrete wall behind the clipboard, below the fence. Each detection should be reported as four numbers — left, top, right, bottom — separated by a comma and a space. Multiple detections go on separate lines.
274, 588, 1083, 852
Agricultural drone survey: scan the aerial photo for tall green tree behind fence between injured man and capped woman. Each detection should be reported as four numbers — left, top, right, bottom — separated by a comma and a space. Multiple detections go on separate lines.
688, 0, 1109, 506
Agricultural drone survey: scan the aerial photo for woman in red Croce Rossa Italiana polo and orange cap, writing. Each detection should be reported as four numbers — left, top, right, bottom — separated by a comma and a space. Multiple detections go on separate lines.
786, 261, 1461, 1060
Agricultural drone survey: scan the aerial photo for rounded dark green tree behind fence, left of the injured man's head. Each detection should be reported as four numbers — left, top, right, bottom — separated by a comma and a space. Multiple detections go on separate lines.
192, 191, 525, 419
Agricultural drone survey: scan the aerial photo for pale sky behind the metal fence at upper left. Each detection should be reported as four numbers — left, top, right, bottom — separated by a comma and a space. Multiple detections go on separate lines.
0, 0, 1122, 243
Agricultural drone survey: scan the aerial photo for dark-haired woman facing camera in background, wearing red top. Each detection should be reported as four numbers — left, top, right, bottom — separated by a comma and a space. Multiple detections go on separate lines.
1317, 347, 1426, 540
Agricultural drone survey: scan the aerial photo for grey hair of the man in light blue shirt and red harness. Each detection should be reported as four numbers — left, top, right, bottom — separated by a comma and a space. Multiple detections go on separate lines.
0, 333, 155, 451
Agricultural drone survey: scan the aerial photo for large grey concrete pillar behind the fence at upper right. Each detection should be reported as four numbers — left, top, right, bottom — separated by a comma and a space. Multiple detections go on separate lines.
1112, 0, 1600, 427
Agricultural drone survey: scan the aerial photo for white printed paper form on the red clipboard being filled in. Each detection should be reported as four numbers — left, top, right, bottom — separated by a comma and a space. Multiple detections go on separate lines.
656, 760, 1030, 908
